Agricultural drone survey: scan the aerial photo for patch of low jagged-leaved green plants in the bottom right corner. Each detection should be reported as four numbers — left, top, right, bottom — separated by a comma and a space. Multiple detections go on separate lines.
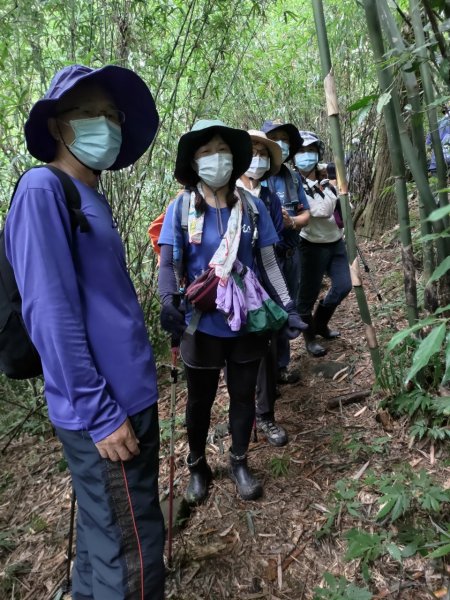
316, 465, 450, 580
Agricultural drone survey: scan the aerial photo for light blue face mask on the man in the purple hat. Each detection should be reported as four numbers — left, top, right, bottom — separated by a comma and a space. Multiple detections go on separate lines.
68, 117, 122, 171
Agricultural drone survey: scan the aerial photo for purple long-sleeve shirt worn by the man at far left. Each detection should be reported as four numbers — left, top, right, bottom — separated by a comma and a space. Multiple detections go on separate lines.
5, 169, 158, 442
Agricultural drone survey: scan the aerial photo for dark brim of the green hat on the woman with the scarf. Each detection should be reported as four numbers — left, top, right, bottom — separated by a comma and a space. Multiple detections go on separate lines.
174, 125, 253, 186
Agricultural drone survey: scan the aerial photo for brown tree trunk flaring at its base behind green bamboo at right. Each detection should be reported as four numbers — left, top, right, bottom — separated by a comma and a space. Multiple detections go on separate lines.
356, 127, 398, 239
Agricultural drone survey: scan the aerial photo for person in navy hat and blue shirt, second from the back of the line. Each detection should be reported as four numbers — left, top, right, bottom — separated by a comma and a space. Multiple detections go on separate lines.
261, 121, 309, 384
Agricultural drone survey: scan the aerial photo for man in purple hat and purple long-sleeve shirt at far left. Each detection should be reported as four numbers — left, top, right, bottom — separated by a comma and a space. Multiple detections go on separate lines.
5, 65, 164, 600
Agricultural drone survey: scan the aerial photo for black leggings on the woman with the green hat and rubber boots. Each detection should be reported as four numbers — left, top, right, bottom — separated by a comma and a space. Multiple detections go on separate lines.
185, 359, 260, 461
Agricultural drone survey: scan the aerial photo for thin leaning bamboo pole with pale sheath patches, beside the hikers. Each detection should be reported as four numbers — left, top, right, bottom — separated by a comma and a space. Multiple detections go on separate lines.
312, 0, 381, 375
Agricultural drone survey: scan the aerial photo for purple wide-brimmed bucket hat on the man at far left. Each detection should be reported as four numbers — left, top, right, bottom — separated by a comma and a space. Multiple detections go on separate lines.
25, 65, 159, 171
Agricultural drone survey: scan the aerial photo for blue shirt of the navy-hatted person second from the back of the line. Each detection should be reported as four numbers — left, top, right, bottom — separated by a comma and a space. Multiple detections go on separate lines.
263, 165, 309, 249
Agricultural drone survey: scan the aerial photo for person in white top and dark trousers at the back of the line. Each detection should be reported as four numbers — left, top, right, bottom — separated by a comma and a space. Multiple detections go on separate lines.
294, 131, 352, 356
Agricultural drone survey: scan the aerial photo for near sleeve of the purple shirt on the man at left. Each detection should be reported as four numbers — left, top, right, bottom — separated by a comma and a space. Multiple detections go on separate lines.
5, 178, 127, 442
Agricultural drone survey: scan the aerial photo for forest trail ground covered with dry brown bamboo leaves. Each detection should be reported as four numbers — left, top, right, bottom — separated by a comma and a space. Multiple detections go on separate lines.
0, 236, 448, 600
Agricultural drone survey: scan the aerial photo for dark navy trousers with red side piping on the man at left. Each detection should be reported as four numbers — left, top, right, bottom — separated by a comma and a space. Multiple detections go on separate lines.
56, 404, 164, 600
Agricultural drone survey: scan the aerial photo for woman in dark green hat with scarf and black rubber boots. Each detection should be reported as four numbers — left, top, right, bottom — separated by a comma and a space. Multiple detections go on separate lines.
159, 120, 306, 504
